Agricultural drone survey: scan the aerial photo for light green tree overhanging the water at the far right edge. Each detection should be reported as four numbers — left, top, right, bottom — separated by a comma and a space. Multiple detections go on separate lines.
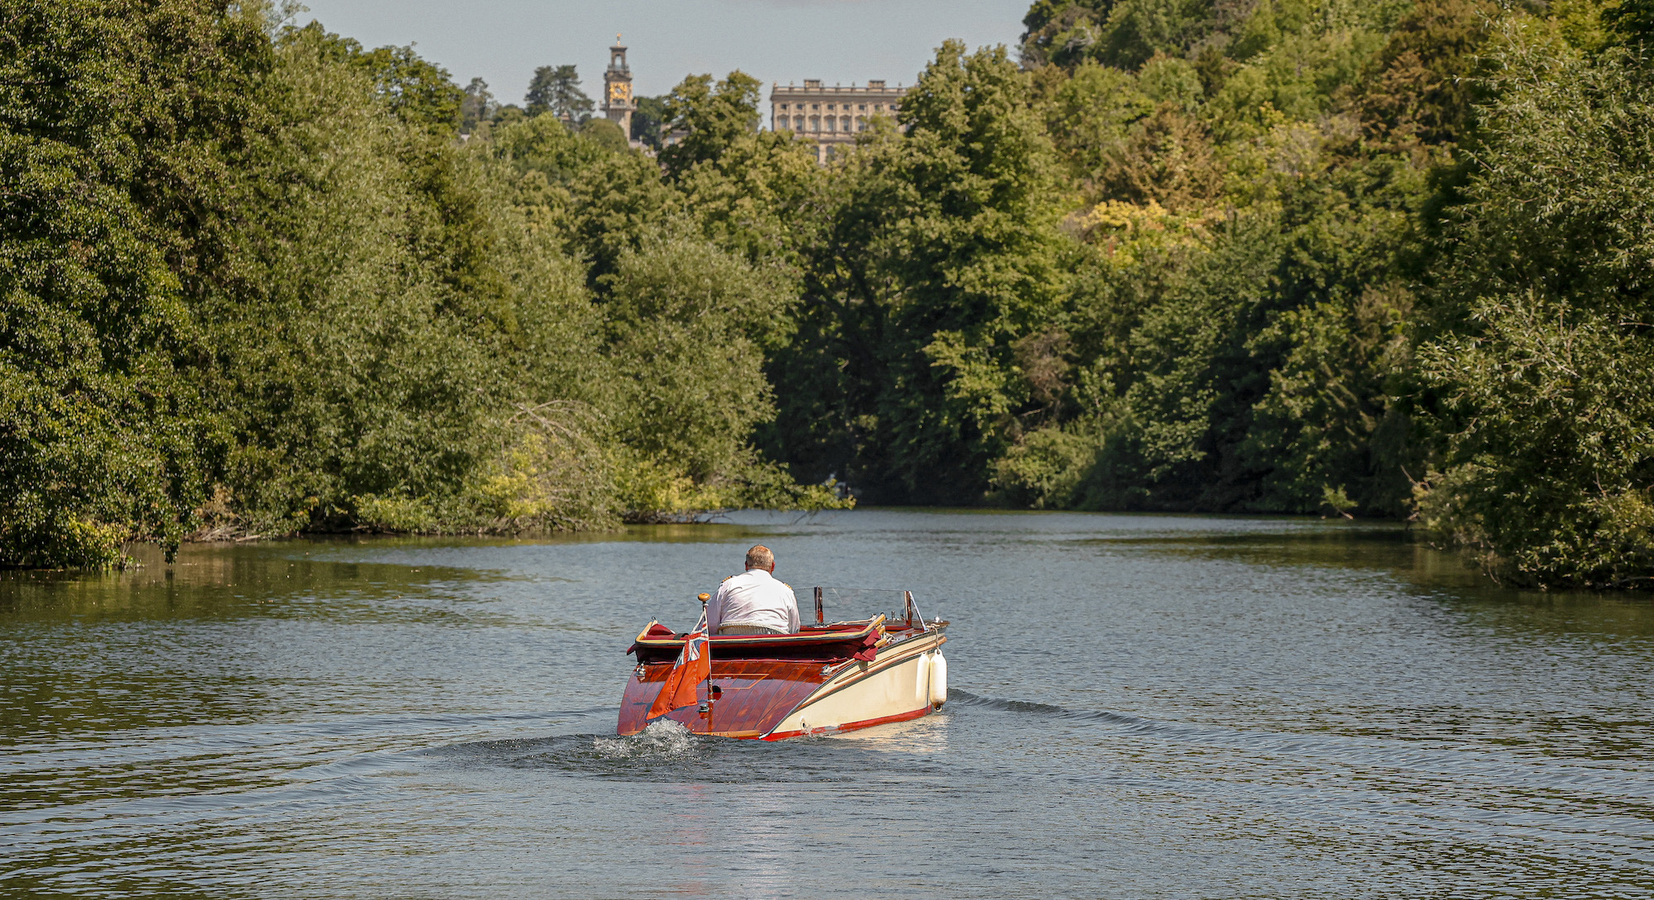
1419, 20, 1654, 587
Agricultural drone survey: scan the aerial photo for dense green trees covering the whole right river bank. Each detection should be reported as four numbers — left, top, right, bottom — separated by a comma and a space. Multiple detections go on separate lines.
764, 0, 1654, 586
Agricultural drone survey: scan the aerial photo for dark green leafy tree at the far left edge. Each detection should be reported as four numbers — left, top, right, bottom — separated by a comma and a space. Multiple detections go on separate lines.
0, 0, 270, 566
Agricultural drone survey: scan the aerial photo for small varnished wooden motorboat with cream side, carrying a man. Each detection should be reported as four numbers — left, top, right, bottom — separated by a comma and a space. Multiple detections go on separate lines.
617, 587, 948, 741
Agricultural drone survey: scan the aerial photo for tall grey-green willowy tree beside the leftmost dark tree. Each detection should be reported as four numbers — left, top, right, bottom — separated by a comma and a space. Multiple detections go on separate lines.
198, 28, 511, 534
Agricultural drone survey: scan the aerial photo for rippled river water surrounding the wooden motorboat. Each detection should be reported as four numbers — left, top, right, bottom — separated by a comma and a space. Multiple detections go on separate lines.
0, 510, 1654, 898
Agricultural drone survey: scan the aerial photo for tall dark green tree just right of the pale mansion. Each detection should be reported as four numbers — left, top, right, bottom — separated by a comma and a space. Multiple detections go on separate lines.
776, 41, 1064, 503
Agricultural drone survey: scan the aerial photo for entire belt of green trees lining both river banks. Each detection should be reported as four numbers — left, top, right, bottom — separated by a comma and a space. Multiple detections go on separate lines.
0, 0, 1654, 587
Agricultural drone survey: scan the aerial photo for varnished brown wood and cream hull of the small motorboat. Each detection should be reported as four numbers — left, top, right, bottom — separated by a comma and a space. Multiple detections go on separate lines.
617, 629, 948, 741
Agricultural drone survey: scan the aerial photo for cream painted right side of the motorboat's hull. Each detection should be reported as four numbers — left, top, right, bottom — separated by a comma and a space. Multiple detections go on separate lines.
766, 634, 944, 738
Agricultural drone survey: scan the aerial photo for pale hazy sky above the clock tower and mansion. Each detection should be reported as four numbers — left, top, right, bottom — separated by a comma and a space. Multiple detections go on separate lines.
299, 0, 1030, 103
